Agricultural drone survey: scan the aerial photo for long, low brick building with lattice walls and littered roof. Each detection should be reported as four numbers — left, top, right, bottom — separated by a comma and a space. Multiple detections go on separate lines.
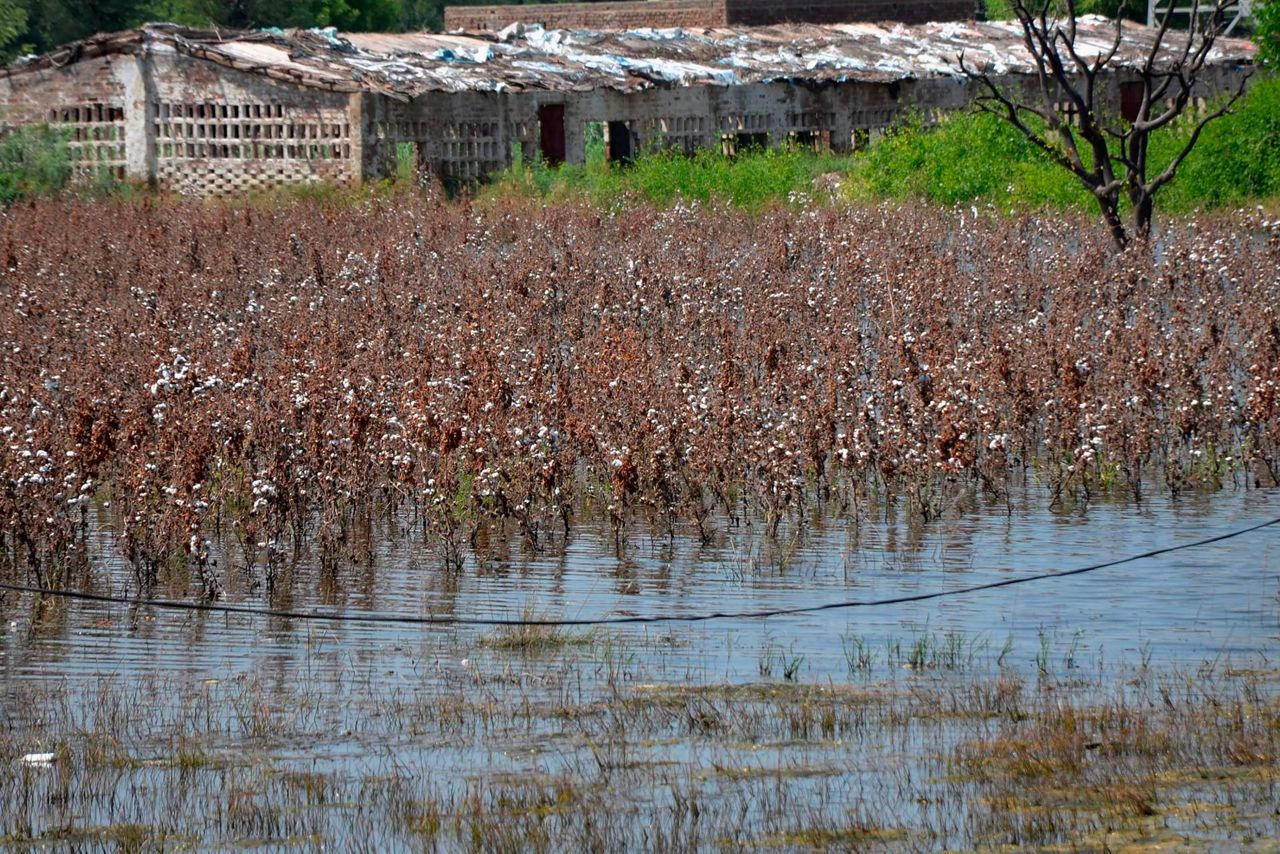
0, 9, 1254, 195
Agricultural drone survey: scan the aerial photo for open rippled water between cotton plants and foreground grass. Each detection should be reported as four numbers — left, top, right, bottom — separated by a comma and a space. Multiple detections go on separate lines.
0, 489, 1280, 689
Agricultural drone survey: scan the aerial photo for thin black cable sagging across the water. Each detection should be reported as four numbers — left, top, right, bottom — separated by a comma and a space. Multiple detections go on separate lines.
0, 517, 1280, 627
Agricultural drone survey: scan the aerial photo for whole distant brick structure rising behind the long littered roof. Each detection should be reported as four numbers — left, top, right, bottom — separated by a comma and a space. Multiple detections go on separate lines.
444, 0, 974, 32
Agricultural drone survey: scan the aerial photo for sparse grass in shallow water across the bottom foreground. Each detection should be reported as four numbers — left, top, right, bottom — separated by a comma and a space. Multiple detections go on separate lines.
0, 652, 1280, 850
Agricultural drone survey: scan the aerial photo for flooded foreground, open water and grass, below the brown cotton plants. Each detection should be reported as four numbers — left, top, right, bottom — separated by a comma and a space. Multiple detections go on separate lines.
0, 489, 1280, 850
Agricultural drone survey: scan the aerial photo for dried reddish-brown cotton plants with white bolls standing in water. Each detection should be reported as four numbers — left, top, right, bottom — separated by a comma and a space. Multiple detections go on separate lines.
0, 195, 1280, 580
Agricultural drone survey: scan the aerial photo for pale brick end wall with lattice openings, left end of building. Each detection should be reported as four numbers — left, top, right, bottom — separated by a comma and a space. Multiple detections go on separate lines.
0, 54, 362, 196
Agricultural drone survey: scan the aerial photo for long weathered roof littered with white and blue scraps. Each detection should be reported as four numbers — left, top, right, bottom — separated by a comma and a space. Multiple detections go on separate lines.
6, 17, 1256, 97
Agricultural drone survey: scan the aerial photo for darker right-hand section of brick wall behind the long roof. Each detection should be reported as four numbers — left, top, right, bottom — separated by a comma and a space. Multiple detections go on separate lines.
726, 0, 975, 27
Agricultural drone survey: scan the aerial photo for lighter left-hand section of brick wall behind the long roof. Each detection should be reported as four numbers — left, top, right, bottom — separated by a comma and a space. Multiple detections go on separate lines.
444, 0, 726, 32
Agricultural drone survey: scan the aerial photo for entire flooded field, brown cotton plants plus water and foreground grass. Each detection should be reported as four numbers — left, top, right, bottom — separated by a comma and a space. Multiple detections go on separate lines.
0, 201, 1280, 851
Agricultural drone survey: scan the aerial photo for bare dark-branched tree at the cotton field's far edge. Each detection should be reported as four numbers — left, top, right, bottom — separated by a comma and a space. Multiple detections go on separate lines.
960, 0, 1248, 248
